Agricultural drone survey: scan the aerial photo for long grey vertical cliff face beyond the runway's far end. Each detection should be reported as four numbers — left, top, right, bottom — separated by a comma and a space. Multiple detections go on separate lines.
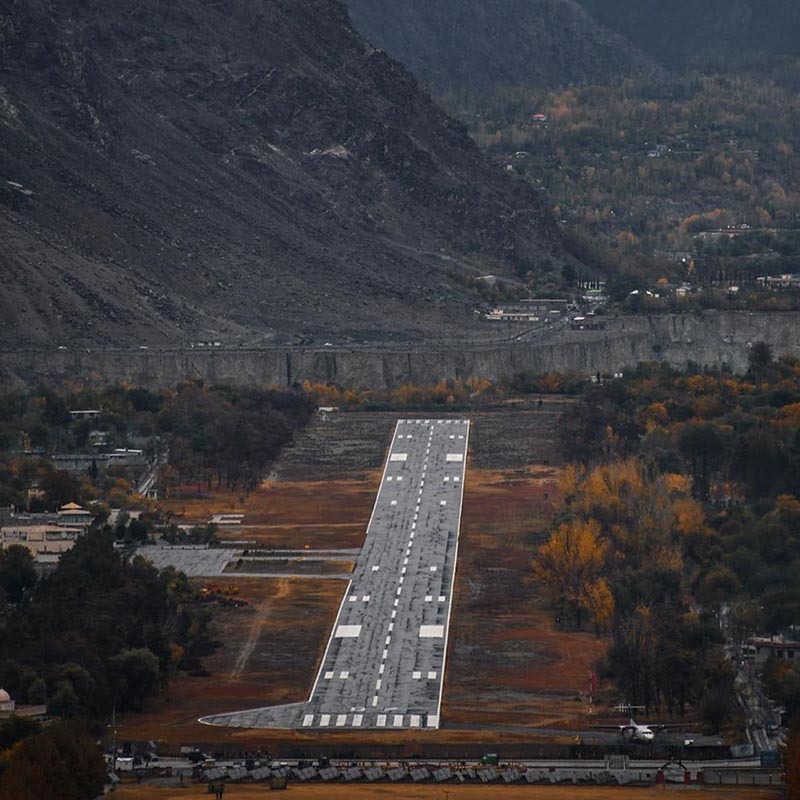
0, 312, 800, 389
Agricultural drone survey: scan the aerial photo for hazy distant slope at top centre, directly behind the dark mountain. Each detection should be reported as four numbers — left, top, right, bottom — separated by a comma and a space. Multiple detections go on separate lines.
347, 0, 658, 89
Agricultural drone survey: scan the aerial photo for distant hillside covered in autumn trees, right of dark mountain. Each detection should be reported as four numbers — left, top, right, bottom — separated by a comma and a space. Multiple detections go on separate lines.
442, 67, 800, 290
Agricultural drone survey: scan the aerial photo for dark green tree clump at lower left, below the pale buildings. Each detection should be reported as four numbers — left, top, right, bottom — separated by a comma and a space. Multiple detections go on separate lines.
0, 531, 210, 719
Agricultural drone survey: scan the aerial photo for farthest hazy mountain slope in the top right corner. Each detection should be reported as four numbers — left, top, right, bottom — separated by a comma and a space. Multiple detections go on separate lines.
581, 0, 800, 67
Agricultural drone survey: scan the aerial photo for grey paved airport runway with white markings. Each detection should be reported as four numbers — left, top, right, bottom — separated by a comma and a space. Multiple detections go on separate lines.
201, 419, 469, 729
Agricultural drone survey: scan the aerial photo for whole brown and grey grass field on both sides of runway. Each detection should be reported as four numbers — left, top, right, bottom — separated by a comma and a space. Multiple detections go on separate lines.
121, 404, 605, 752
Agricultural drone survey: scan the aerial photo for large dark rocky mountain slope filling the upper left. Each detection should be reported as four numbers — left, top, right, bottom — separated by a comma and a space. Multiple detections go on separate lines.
0, 0, 560, 347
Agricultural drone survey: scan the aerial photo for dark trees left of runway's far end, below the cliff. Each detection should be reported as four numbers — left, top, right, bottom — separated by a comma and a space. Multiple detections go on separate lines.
0, 382, 314, 511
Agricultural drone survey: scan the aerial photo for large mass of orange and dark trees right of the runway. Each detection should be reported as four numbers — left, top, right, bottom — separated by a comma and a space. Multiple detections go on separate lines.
534, 350, 800, 723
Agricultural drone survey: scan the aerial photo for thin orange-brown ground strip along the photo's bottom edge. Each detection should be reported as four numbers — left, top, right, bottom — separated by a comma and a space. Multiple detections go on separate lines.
114, 784, 781, 800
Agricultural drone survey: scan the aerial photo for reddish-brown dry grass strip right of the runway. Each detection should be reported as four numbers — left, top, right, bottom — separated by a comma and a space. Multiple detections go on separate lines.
444, 467, 605, 727
